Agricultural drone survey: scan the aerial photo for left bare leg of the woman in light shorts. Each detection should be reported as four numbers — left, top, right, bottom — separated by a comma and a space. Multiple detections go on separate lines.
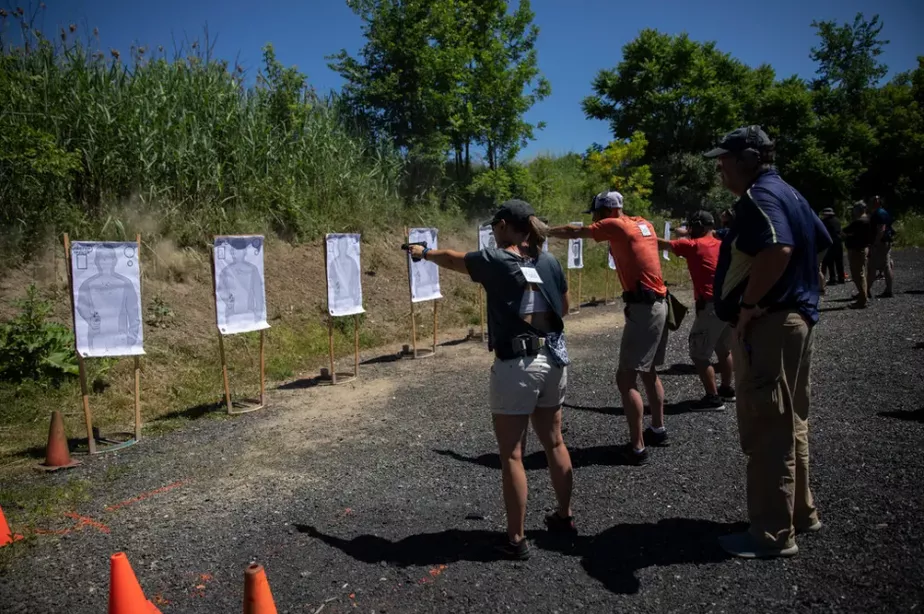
494, 414, 529, 543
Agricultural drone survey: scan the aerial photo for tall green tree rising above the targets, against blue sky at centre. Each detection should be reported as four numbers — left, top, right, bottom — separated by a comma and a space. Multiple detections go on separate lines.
330, 0, 550, 195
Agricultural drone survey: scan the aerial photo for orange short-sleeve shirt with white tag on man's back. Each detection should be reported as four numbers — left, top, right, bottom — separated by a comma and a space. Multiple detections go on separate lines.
589, 215, 667, 296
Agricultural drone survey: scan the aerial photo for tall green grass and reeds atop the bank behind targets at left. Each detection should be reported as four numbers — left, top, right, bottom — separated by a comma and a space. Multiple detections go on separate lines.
0, 24, 402, 255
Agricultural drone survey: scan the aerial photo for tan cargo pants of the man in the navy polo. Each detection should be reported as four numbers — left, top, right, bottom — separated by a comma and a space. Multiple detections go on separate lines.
732, 311, 818, 548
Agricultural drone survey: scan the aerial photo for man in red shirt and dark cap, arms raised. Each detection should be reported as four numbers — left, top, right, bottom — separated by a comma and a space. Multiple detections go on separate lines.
658, 211, 735, 410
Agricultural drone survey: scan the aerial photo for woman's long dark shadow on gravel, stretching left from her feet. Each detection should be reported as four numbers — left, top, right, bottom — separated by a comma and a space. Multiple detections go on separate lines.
295, 524, 503, 567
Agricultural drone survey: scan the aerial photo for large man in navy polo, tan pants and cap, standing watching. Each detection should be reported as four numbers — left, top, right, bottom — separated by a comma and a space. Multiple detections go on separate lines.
705, 126, 831, 558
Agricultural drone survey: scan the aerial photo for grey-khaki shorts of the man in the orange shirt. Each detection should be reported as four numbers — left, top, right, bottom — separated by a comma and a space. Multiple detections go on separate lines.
619, 299, 667, 371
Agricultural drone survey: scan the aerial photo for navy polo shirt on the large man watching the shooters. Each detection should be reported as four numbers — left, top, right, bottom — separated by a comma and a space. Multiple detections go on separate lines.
714, 170, 831, 323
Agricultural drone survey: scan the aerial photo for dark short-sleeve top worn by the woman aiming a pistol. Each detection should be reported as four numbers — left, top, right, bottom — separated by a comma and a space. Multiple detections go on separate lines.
465, 248, 568, 350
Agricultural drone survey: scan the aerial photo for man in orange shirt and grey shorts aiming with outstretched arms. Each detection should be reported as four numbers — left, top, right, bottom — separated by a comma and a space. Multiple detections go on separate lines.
549, 192, 667, 465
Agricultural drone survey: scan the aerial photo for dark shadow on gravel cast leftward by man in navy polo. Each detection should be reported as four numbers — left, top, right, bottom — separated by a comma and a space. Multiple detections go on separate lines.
530, 518, 747, 595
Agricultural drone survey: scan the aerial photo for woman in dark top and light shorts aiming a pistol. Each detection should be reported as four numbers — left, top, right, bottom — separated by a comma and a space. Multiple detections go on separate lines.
407, 200, 577, 560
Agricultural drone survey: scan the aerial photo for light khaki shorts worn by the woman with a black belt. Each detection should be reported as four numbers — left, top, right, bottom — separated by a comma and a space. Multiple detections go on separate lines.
490, 348, 568, 416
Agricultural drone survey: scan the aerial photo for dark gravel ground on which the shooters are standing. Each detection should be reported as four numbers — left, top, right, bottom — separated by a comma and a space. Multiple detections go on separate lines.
0, 250, 924, 614
